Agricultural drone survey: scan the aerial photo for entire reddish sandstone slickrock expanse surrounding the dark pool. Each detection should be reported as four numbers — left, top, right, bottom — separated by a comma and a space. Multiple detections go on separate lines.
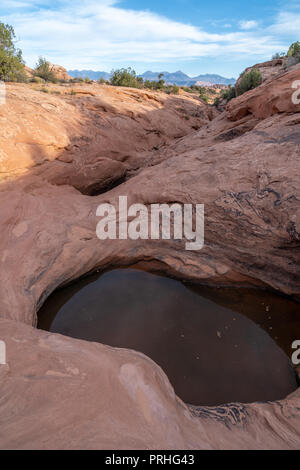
0, 71, 300, 449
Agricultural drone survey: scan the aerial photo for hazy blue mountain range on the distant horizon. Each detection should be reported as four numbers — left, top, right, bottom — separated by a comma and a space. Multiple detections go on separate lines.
68, 70, 236, 86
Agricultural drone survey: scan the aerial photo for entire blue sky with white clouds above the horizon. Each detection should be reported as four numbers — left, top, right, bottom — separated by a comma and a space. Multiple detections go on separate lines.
0, 0, 300, 77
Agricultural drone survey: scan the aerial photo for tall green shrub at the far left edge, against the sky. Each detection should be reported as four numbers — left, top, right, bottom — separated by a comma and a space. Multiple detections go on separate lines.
0, 22, 27, 82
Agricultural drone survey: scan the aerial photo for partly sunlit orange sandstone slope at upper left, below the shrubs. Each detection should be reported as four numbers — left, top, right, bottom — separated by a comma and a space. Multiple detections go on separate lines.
0, 84, 213, 184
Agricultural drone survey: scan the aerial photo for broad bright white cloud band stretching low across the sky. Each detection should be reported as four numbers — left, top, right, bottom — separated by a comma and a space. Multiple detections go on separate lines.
0, 0, 292, 70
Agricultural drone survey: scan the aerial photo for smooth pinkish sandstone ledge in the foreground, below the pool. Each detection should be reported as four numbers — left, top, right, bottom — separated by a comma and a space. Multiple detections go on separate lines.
0, 319, 300, 450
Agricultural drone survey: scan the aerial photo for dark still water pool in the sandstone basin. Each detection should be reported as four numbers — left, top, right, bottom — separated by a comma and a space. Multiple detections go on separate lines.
38, 269, 300, 405
